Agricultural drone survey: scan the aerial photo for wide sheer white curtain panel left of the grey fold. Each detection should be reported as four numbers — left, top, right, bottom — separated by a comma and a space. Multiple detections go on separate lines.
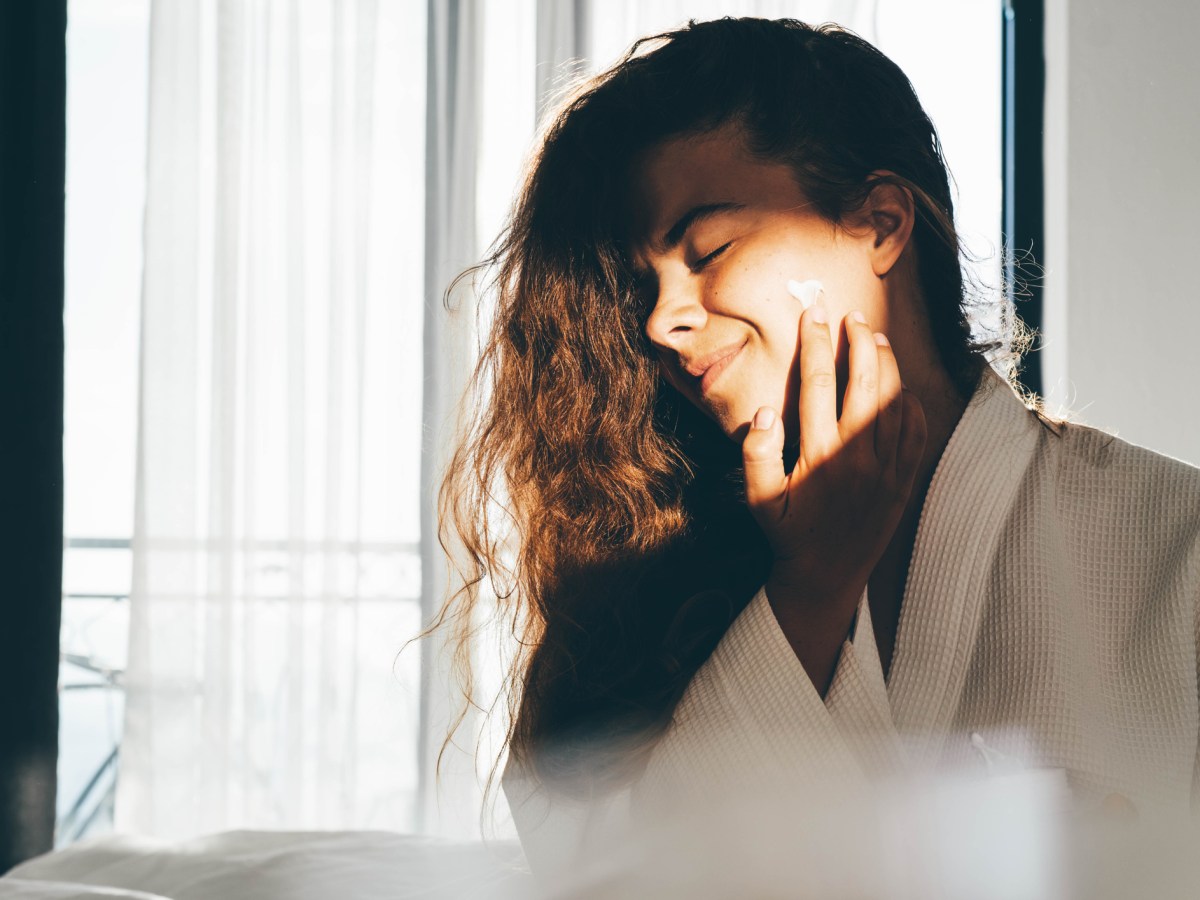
118, 0, 426, 836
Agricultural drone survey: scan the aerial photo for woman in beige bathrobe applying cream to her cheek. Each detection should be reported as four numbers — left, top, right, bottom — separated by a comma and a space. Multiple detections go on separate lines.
442, 19, 1200, 883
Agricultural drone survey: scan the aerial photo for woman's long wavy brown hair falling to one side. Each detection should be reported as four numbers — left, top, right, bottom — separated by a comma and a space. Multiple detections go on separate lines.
431, 12, 1020, 792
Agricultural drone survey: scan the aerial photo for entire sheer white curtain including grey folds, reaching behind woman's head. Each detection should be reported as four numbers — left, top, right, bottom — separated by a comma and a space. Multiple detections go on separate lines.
116, 0, 998, 836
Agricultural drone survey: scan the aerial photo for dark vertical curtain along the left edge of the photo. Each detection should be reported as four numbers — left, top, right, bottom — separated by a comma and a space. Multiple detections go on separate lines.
0, 0, 67, 871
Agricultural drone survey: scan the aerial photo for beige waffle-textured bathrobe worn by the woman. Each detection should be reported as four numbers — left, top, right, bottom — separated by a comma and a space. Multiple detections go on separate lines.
504, 371, 1200, 873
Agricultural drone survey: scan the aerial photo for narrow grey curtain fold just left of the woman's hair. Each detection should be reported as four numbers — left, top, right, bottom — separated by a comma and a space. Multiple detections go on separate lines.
416, 0, 487, 836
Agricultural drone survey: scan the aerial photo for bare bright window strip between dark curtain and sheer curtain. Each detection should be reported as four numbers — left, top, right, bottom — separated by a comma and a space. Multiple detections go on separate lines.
58, 0, 150, 844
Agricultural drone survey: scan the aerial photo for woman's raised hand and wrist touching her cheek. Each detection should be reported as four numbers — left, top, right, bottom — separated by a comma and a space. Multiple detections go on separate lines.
742, 301, 925, 689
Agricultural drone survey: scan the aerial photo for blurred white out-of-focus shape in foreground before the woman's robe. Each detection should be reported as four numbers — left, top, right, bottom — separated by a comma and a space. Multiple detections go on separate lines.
546, 769, 1200, 900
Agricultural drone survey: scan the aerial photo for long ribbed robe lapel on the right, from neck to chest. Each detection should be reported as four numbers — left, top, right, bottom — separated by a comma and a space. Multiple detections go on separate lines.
888, 368, 1040, 764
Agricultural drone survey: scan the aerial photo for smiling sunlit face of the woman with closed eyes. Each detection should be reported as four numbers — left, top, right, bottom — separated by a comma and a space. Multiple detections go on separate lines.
631, 126, 899, 442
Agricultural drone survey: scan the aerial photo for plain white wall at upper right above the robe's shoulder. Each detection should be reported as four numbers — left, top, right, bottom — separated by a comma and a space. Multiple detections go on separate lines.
1042, 0, 1200, 464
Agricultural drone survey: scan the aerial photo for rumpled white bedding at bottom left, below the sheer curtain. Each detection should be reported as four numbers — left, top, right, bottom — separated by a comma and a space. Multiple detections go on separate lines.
0, 832, 534, 900
